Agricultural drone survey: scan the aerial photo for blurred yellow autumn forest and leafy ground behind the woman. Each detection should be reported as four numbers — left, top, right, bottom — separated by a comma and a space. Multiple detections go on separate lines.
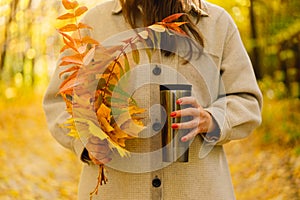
0, 0, 300, 200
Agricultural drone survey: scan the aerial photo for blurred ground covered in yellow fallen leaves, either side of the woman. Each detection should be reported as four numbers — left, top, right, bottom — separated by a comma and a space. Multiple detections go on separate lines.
0, 95, 300, 200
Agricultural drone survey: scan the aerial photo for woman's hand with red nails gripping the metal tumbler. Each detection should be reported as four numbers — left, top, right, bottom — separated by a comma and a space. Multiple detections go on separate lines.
170, 97, 216, 142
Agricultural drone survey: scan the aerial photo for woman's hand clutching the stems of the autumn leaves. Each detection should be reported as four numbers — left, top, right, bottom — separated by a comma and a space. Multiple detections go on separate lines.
86, 136, 111, 165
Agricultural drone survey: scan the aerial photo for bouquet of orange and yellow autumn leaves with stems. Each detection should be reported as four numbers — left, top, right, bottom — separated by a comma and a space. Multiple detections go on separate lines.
57, 0, 190, 197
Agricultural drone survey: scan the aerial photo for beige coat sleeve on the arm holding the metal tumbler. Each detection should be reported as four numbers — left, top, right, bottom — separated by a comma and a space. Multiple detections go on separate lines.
206, 11, 262, 145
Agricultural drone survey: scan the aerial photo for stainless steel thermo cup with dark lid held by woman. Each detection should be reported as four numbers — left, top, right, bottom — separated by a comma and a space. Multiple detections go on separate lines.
160, 84, 192, 162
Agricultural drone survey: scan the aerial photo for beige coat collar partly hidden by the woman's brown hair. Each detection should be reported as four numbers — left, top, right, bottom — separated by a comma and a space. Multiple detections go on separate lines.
112, 0, 209, 17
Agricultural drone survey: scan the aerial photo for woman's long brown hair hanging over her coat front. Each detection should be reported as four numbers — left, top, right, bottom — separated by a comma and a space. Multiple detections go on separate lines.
120, 0, 203, 46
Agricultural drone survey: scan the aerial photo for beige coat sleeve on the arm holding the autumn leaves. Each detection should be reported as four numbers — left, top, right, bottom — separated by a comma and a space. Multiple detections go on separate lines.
43, 54, 84, 158
